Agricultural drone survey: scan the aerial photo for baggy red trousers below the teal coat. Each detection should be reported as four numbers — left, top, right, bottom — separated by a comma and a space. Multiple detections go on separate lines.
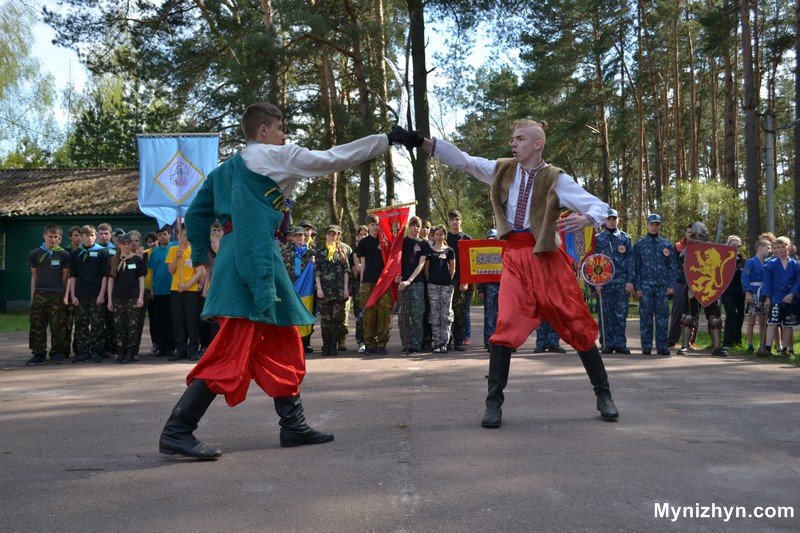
186, 317, 306, 407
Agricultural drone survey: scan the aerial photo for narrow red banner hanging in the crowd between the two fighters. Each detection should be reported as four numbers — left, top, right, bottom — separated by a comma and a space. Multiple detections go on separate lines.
364, 207, 411, 307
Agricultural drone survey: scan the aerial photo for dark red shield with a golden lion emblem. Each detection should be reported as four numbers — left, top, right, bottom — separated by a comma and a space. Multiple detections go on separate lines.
683, 241, 736, 307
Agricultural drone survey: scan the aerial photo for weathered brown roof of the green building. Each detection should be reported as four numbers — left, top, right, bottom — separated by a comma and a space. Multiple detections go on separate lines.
0, 168, 142, 216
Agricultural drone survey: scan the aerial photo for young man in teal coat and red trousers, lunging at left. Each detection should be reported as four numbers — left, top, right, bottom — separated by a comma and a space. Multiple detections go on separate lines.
159, 104, 406, 459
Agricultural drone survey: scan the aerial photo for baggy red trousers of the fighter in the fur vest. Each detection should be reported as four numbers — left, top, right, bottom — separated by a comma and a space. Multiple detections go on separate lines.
489, 232, 598, 352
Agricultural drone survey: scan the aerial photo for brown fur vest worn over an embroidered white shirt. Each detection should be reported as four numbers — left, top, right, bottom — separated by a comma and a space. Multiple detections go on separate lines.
490, 158, 564, 254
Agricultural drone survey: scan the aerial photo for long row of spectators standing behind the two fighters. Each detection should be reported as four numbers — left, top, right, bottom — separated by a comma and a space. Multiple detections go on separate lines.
21, 209, 800, 366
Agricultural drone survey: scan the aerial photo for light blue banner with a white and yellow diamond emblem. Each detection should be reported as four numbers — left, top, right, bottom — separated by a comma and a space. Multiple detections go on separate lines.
136, 133, 219, 227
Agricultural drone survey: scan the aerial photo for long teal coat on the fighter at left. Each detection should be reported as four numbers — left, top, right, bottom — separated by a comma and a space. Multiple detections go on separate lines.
186, 154, 316, 326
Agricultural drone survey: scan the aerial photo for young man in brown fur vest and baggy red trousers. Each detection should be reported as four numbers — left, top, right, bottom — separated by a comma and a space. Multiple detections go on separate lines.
406, 120, 619, 428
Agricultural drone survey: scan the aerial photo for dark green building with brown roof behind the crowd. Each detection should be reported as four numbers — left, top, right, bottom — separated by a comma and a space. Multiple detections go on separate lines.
0, 168, 157, 313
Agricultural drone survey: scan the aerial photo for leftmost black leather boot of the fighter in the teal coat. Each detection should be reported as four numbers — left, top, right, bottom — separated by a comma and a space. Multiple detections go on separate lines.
158, 379, 222, 461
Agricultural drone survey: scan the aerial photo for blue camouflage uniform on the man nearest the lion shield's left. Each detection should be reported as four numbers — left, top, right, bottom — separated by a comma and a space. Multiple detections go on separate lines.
633, 234, 677, 352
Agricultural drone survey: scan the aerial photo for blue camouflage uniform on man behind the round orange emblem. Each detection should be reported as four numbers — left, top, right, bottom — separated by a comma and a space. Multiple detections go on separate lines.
594, 228, 636, 353
